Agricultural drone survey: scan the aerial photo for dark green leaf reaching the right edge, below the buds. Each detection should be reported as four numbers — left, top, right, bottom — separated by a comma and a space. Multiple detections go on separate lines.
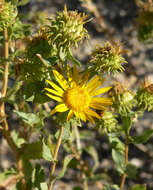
129, 129, 153, 144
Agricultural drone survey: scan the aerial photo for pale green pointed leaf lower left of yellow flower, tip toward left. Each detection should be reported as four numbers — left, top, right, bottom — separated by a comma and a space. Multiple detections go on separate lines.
14, 110, 40, 126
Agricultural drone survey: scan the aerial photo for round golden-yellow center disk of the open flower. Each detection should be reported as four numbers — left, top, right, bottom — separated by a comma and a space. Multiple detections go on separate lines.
64, 87, 91, 112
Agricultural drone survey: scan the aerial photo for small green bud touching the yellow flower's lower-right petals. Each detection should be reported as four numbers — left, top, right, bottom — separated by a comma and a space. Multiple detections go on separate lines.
96, 111, 118, 134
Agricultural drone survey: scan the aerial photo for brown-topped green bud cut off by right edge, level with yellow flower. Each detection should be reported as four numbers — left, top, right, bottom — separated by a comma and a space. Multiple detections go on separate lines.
135, 80, 153, 111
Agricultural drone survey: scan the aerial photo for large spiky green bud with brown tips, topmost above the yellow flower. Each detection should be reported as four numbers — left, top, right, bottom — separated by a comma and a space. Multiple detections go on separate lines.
48, 6, 88, 49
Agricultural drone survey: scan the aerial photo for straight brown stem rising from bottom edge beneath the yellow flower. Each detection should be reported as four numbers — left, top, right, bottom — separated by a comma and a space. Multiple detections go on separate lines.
48, 126, 64, 190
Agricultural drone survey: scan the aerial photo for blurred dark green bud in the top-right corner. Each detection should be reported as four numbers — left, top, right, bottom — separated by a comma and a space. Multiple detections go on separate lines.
137, 3, 153, 42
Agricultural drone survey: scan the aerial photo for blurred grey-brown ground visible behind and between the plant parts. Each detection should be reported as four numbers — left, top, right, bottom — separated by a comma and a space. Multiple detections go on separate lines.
0, 0, 153, 190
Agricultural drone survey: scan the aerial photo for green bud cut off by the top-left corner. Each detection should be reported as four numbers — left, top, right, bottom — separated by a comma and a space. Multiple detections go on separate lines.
0, 0, 17, 30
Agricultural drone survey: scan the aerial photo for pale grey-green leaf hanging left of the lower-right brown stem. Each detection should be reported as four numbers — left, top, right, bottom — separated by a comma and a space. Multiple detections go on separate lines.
112, 149, 126, 174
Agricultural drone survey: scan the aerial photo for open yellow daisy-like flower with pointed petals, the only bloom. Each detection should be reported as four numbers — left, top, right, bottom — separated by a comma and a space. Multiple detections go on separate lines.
45, 65, 112, 123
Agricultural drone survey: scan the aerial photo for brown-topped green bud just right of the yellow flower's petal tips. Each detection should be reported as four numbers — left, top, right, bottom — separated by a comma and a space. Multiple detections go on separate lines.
110, 82, 136, 116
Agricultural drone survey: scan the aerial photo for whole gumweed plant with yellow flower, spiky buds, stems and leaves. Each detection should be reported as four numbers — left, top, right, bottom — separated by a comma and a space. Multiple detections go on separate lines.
0, 0, 153, 190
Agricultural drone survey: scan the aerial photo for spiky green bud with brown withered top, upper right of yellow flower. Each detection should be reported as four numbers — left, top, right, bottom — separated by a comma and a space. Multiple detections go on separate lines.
89, 42, 127, 74
